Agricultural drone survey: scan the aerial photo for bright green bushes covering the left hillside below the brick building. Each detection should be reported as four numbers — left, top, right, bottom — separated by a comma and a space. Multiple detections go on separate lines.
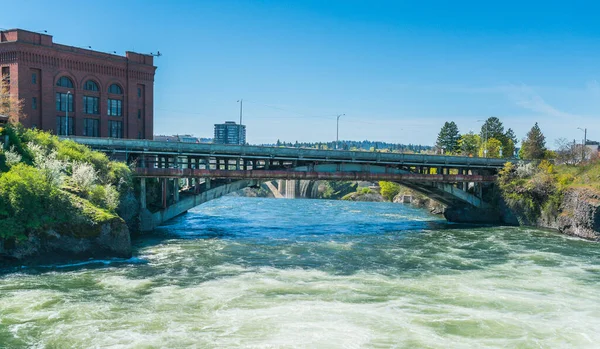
0, 126, 133, 239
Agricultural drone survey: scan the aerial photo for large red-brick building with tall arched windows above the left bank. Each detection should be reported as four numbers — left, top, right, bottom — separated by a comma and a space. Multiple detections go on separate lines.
0, 29, 156, 139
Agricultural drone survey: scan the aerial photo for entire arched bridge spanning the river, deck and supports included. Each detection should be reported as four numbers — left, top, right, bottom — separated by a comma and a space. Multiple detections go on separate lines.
69, 137, 510, 231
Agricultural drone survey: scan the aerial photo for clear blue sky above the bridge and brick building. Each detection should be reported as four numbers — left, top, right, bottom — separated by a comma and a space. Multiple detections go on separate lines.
0, 0, 600, 146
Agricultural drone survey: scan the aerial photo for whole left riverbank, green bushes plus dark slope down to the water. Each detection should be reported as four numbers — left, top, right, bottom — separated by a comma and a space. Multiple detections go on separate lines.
0, 125, 137, 260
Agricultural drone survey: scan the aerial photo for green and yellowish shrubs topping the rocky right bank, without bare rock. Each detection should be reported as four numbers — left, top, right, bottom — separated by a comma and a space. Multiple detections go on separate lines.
498, 160, 600, 224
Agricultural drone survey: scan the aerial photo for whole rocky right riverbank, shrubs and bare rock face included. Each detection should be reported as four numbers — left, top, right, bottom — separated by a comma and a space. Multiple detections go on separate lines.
498, 161, 600, 241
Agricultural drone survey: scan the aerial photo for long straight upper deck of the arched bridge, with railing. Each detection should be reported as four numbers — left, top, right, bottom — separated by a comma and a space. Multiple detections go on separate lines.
70, 137, 515, 169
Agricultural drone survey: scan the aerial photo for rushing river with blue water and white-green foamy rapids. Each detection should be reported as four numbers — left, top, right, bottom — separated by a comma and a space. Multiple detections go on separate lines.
0, 197, 600, 349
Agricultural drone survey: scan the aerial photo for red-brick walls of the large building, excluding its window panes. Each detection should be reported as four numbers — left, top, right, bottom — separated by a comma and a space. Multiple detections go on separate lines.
0, 30, 156, 139
